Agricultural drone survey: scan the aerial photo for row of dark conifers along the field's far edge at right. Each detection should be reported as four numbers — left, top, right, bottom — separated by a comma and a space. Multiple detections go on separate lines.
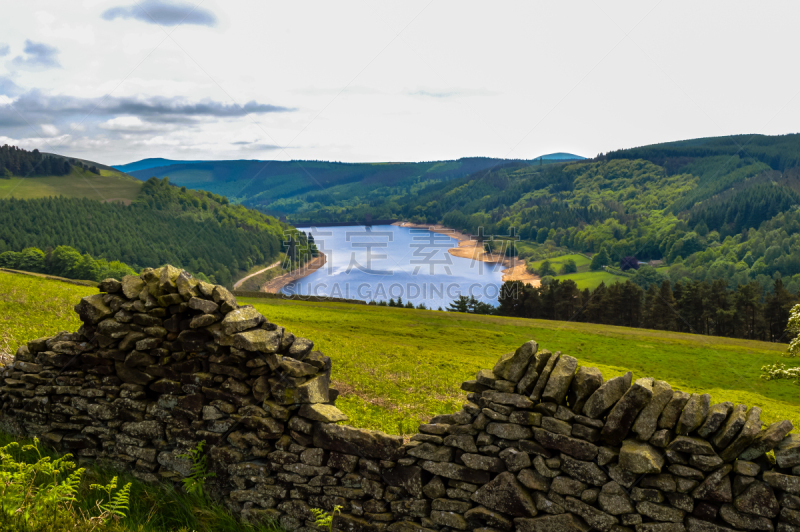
491, 278, 798, 342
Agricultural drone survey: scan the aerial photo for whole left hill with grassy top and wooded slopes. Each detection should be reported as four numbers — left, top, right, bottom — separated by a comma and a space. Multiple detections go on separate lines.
0, 147, 305, 285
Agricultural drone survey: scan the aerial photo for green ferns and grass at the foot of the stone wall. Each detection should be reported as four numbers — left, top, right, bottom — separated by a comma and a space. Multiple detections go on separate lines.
0, 433, 281, 532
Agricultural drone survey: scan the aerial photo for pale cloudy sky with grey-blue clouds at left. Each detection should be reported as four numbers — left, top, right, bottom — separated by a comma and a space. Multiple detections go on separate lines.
0, 0, 800, 164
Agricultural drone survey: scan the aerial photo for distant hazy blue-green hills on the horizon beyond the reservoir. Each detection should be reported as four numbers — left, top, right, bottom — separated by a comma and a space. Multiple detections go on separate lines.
120, 153, 580, 215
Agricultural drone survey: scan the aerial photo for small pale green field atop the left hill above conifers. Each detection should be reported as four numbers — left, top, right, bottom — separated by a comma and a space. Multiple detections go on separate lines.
0, 167, 142, 202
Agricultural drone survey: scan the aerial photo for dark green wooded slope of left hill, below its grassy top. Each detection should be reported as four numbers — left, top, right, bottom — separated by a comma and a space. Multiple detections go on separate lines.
0, 178, 304, 284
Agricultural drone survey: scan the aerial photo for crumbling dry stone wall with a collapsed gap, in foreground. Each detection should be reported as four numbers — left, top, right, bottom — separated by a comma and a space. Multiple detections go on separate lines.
0, 266, 800, 532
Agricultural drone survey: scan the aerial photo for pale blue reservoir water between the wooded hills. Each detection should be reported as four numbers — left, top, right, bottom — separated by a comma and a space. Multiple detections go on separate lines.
282, 225, 503, 309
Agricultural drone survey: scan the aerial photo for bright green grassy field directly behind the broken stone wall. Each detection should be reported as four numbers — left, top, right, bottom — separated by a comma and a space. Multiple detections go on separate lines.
0, 272, 800, 434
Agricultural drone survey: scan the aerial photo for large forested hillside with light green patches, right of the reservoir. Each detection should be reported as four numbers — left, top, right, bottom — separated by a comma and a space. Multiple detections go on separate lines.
289, 135, 800, 293
